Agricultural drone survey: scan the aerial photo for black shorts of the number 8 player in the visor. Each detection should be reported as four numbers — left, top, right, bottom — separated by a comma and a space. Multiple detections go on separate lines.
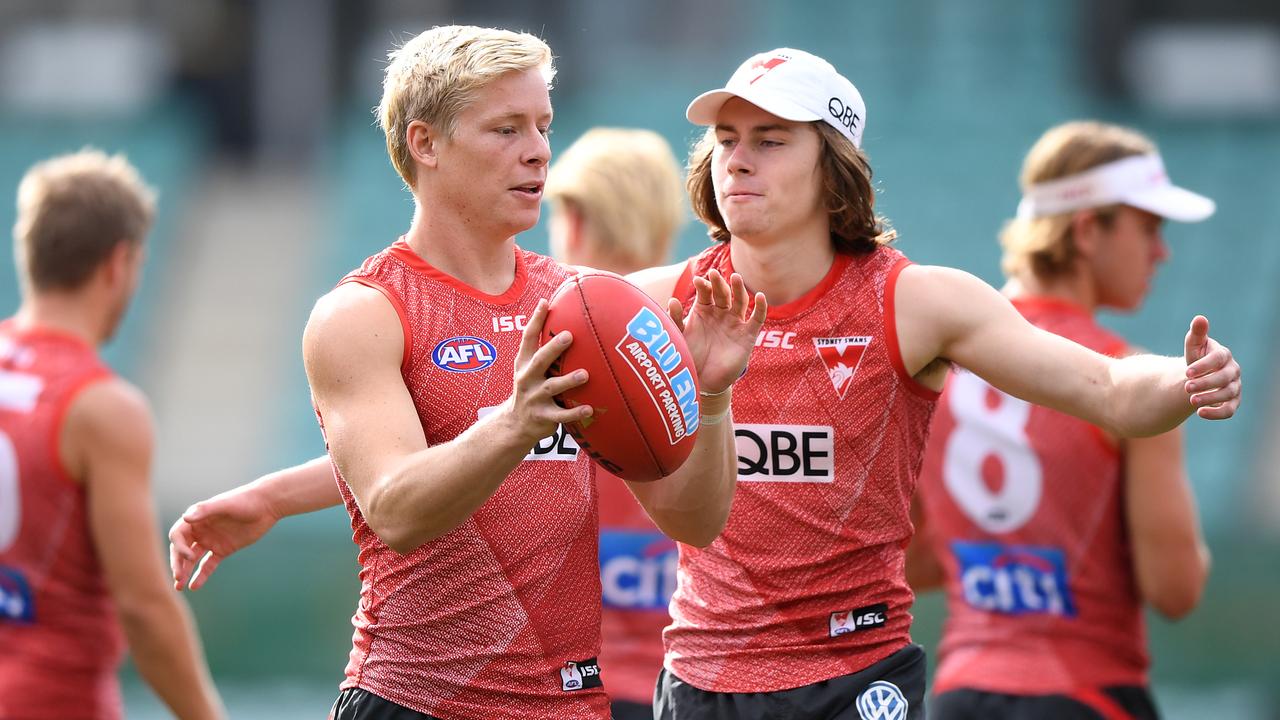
929, 687, 1160, 720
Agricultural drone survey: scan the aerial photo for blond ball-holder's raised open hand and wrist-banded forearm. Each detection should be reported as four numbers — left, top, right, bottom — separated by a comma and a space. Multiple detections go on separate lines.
627, 265, 768, 547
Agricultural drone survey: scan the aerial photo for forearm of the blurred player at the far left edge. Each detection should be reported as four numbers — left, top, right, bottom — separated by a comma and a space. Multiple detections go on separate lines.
120, 594, 227, 720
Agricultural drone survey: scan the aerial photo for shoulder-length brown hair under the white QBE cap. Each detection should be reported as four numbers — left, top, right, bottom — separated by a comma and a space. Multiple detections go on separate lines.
687, 122, 897, 254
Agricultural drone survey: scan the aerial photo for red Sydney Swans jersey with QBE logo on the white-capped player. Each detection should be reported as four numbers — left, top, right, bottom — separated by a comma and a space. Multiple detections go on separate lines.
664, 243, 937, 692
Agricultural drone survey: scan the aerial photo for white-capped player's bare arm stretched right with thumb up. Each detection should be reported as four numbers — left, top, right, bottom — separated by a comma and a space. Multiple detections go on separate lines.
897, 265, 1240, 437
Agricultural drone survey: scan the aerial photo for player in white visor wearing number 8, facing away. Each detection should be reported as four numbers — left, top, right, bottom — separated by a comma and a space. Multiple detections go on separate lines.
909, 122, 1213, 720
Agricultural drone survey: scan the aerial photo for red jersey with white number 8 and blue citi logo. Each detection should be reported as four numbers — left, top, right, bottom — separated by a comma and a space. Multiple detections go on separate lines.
920, 299, 1148, 694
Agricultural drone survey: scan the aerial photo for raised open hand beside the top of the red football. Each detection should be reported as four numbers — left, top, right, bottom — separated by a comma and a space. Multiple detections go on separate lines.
667, 269, 769, 395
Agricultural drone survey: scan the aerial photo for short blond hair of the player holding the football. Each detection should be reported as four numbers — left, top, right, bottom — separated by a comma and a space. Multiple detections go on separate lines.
376, 26, 556, 187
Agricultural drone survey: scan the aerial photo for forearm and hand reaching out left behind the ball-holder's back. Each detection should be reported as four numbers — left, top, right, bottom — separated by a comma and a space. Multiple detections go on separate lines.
169, 455, 342, 591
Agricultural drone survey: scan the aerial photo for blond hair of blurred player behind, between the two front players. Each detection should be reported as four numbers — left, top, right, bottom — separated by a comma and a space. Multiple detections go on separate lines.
545, 128, 685, 268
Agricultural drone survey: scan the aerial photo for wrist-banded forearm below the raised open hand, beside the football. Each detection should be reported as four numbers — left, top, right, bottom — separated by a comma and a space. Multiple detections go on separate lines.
628, 391, 737, 547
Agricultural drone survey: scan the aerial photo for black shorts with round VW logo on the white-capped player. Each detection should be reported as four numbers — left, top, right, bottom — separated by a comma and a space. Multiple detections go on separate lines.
653, 644, 925, 720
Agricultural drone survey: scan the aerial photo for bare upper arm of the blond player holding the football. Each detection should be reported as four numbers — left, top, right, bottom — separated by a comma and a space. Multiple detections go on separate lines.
303, 280, 428, 500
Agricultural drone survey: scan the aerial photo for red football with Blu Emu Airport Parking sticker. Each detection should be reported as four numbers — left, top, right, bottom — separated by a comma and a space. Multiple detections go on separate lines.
541, 272, 698, 482
